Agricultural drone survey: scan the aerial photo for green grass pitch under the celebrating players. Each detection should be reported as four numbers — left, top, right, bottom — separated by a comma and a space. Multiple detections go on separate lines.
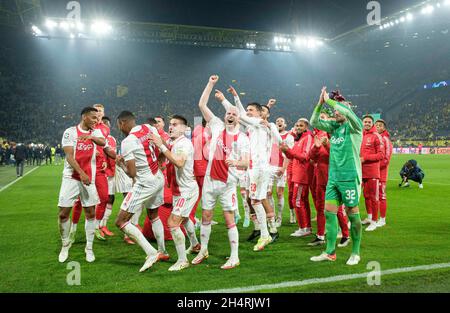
0, 155, 450, 293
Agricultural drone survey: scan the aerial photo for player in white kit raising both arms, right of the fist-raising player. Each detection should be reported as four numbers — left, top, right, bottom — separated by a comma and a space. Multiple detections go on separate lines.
216, 88, 281, 251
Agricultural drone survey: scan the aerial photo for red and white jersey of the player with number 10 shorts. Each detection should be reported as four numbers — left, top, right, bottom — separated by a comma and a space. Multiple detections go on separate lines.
167, 135, 198, 196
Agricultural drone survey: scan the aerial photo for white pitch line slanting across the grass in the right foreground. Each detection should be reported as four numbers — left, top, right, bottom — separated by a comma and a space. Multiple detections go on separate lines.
198, 263, 450, 293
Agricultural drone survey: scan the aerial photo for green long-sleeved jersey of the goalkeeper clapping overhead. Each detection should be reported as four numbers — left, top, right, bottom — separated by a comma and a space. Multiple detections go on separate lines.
311, 99, 363, 183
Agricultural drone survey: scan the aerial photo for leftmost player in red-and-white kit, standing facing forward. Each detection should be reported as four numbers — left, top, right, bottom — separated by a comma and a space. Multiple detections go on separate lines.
58, 107, 106, 262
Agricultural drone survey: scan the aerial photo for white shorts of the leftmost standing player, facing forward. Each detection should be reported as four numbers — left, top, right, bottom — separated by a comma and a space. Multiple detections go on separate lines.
58, 177, 100, 208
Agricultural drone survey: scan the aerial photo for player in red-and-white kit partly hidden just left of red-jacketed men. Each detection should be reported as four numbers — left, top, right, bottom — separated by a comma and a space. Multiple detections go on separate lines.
267, 117, 294, 227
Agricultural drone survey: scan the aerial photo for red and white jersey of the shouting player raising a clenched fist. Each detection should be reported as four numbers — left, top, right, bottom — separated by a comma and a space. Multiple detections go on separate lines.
206, 116, 250, 184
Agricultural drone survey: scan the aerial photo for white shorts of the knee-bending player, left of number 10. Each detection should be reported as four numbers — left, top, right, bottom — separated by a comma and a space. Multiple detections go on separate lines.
120, 171, 164, 214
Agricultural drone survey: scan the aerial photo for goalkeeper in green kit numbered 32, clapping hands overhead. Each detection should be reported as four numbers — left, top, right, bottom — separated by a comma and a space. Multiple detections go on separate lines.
311, 87, 363, 265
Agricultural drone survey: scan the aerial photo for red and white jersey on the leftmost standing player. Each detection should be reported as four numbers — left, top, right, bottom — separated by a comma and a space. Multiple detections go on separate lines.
61, 125, 104, 182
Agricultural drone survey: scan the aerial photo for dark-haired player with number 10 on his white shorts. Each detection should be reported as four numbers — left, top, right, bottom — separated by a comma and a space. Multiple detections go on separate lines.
152, 115, 199, 271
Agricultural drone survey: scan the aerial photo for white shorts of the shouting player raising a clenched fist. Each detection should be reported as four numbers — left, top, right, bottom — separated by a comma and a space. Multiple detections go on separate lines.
202, 176, 238, 211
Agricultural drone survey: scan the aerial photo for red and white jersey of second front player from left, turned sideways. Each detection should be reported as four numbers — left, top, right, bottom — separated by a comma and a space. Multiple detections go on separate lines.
121, 124, 160, 183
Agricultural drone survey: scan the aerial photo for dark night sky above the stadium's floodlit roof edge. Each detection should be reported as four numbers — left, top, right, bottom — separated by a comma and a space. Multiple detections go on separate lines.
41, 0, 422, 38
